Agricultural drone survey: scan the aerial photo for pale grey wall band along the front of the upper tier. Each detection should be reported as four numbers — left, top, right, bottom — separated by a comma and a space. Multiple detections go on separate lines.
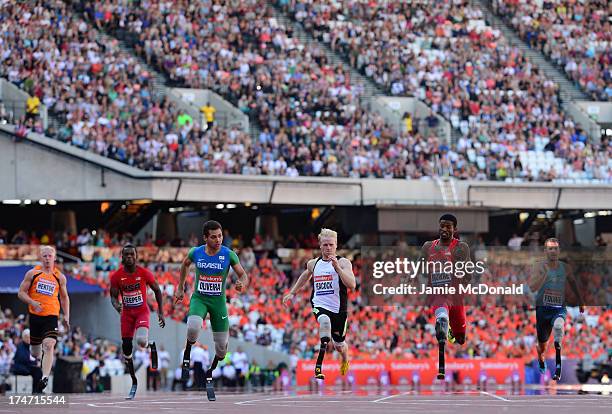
0, 125, 612, 210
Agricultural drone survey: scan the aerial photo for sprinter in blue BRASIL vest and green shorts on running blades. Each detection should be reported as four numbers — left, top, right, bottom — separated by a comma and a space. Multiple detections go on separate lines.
174, 220, 248, 401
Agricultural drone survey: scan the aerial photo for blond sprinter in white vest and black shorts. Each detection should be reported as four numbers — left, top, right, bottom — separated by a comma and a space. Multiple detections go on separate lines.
283, 229, 356, 379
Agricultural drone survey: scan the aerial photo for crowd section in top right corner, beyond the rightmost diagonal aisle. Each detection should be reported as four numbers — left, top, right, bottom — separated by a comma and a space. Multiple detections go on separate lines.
492, 0, 612, 101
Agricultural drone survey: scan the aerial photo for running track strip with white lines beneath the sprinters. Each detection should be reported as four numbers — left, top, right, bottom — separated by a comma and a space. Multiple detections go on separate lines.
0, 391, 612, 414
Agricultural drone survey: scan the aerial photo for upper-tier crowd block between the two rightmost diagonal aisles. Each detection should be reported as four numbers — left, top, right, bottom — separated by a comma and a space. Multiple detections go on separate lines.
278, 0, 612, 181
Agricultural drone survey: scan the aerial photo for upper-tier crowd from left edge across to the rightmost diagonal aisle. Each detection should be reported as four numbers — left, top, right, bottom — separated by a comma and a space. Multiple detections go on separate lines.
0, 0, 612, 181
